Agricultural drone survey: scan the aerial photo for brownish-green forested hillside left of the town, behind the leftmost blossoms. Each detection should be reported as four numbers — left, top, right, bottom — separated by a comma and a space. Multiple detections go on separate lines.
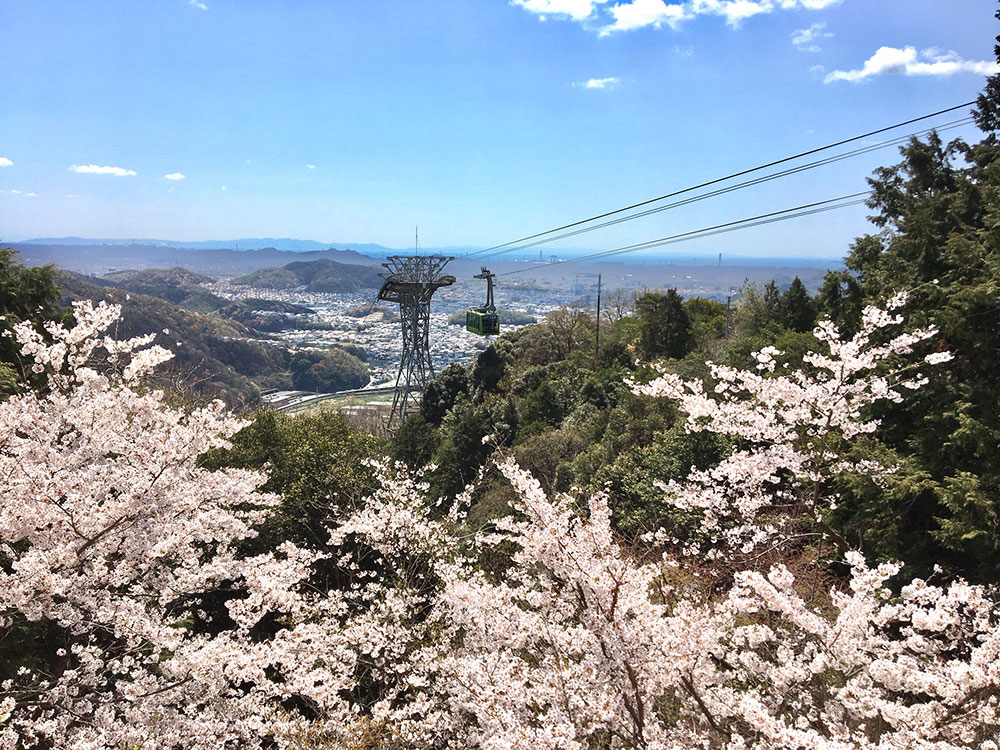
0, 262, 369, 409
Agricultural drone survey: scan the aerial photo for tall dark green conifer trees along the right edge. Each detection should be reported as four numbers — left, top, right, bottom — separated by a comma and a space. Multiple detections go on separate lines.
828, 67, 1000, 582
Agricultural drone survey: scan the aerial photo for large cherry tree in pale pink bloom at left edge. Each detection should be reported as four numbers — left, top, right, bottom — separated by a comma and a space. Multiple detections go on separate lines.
0, 302, 353, 748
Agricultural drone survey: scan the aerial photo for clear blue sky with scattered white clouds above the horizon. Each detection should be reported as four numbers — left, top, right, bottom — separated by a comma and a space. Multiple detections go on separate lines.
0, 0, 998, 257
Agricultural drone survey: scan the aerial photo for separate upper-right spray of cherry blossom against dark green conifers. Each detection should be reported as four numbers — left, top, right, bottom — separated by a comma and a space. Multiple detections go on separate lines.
632, 294, 951, 555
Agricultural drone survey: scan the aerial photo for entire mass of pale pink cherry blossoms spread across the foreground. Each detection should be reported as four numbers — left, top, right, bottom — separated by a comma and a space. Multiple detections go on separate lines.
0, 299, 1000, 750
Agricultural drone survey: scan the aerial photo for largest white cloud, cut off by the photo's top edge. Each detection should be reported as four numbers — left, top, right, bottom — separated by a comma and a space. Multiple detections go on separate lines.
513, 0, 841, 36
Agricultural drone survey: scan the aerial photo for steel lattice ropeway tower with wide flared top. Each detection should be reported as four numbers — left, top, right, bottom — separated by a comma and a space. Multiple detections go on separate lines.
378, 255, 455, 430
